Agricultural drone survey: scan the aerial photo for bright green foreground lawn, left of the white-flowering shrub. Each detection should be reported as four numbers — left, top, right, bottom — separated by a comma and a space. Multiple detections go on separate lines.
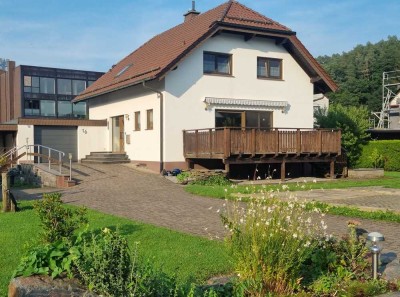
0, 201, 232, 296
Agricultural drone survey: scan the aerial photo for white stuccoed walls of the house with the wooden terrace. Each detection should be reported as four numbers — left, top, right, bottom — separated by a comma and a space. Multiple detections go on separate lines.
86, 33, 313, 168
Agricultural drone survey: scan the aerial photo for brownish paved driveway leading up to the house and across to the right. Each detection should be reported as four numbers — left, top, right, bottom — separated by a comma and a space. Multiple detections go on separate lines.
14, 164, 400, 253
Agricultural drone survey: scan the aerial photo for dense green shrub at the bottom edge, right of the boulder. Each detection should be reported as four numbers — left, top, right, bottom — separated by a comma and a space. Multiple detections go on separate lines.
75, 228, 183, 297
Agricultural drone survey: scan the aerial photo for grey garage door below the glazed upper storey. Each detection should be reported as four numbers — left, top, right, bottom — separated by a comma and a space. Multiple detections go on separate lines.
34, 126, 78, 162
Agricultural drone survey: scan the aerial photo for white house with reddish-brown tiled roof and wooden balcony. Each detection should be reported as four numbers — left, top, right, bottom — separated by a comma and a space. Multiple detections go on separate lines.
73, 1, 340, 176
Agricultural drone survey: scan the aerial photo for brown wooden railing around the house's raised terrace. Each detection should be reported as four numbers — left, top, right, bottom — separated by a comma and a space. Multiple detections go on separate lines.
183, 128, 341, 159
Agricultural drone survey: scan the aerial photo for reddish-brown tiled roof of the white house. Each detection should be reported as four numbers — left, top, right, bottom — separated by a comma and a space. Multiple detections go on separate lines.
73, 0, 336, 102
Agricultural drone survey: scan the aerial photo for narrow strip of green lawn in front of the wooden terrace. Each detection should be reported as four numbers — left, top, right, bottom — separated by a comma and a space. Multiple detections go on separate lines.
185, 172, 400, 199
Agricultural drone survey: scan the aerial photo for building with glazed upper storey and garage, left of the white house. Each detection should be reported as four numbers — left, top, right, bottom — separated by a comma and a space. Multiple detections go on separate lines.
0, 60, 107, 161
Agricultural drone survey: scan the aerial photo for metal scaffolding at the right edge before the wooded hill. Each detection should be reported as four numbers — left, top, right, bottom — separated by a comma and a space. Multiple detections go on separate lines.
372, 70, 400, 129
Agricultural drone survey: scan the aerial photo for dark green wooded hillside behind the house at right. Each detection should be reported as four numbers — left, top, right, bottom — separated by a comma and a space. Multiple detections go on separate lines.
317, 36, 400, 111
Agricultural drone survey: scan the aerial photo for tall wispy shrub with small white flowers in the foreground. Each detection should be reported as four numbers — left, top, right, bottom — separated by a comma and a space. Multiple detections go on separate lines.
222, 187, 326, 296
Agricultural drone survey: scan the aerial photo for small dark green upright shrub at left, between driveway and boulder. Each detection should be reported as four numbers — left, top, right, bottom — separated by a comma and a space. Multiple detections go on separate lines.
33, 193, 88, 242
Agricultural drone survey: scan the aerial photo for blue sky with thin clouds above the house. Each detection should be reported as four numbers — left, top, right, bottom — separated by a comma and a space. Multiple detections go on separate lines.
0, 0, 400, 71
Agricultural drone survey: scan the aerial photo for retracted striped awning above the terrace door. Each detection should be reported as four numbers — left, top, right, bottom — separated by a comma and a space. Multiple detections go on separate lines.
204, 97, 289, 109
